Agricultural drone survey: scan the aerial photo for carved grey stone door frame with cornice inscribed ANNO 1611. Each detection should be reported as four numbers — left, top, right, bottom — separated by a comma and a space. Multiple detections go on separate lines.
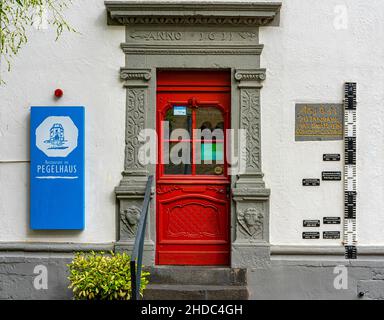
105, 1, 281, 267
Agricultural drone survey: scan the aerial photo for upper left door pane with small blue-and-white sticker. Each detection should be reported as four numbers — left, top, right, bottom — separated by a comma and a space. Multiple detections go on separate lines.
164, 106, 192, 139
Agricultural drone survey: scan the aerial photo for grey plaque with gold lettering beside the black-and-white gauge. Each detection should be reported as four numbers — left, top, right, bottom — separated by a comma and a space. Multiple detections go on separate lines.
295, 103, 344, 141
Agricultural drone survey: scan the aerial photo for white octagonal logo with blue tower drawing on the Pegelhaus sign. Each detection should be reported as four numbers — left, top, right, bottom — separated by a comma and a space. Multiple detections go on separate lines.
36, 116, 78, 157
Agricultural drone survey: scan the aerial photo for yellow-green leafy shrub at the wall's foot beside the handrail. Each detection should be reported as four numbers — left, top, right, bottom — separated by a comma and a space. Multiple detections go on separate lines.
68, 251, 149, 300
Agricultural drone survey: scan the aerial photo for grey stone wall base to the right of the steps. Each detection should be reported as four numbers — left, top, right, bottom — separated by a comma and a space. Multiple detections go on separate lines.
248, 258, 384, 300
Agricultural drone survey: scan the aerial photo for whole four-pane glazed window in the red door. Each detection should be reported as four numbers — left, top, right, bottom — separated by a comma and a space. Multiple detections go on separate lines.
163, 105, 225, 176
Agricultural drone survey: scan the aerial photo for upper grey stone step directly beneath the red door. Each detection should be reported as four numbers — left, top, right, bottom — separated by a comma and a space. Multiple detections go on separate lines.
146, 266, 247, 286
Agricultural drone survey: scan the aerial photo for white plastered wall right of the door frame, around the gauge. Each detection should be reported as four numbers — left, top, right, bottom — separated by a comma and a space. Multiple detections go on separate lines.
260, 0, 384, 245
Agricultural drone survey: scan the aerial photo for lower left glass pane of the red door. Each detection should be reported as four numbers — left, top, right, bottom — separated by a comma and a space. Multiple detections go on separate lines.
164, 141, 192, 174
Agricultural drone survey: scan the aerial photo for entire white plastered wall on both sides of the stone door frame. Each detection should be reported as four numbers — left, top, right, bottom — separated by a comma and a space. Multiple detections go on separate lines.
0, 0, 384, 245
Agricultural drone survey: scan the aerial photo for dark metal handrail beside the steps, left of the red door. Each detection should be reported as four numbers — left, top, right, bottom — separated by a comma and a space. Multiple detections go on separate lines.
130, 176, 153, 300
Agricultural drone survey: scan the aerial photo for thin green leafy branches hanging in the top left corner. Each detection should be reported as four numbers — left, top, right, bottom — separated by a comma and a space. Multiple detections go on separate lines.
0, 0, 75, 79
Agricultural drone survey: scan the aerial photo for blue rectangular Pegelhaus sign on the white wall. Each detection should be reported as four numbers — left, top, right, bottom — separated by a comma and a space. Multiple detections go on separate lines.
30, 107, 84, 230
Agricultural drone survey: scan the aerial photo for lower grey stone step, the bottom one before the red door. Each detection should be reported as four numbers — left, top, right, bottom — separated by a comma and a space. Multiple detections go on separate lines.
144, 284, 249, 300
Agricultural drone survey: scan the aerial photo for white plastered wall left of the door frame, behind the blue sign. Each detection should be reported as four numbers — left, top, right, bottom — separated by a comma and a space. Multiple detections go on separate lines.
0, 0, 125, 243
